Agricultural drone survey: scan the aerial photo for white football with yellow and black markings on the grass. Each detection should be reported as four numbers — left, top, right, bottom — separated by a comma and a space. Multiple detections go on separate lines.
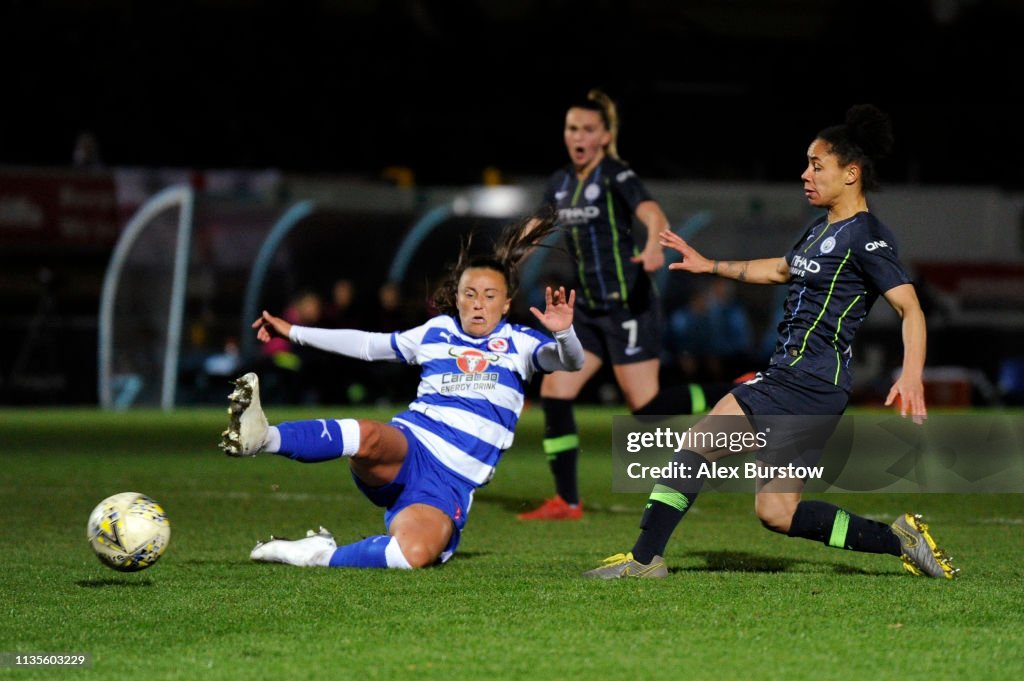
85, 492, 171, 572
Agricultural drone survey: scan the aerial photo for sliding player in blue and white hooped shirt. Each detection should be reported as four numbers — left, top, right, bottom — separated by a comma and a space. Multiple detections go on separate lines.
220, 219, 583, 568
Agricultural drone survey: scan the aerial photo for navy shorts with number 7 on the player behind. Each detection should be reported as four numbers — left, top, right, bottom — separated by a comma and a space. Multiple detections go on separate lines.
572, 305, 665, 365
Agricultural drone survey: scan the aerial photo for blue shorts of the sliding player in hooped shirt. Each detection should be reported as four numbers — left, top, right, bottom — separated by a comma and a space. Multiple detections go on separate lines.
352, 422, 476, 562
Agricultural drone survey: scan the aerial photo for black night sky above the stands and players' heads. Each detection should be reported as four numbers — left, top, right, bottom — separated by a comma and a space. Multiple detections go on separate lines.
6, 0, 1024, 188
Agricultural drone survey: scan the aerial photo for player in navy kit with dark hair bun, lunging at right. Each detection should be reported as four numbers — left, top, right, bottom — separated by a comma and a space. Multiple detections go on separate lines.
586, 104, 956, 579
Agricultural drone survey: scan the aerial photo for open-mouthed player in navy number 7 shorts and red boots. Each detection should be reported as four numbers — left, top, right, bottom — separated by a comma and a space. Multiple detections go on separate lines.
519, 90, 731, 520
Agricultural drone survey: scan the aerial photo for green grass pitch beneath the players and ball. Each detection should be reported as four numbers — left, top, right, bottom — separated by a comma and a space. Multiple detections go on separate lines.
0, 408, 1024, 681
